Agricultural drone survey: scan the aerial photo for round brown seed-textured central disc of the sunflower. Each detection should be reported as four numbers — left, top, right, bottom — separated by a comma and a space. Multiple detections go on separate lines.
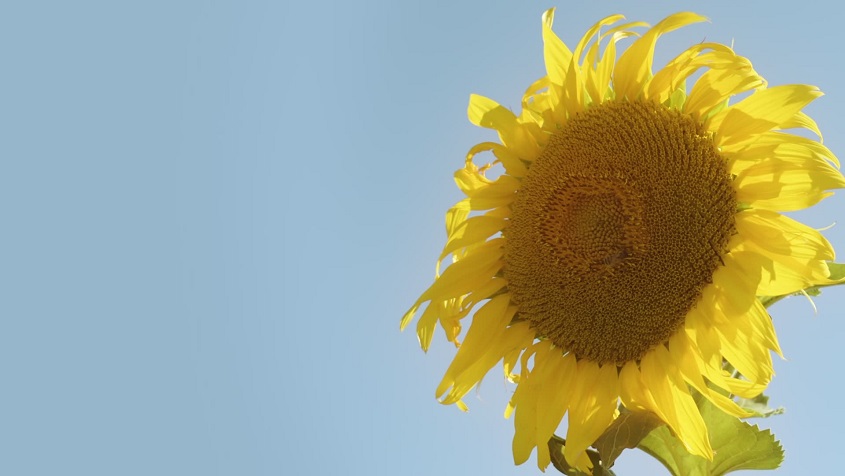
504, 101, 737, 364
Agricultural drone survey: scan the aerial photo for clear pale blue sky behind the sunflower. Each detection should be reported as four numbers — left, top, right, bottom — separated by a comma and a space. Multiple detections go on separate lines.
0, 0, 845, 476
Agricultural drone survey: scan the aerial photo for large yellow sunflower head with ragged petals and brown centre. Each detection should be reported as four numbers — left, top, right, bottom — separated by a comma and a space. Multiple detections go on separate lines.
401, 9, 845, 471
